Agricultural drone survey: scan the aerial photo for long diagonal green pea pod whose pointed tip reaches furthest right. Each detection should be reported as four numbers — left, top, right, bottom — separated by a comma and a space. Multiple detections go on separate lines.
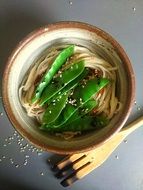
53, 78, 109, 127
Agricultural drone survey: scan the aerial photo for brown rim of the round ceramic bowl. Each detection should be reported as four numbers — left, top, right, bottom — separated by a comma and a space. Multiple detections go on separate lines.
2, 21, 135, 154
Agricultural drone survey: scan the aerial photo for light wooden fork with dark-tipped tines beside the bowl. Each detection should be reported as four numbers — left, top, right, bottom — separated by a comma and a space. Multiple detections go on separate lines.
52, 116, 143, 187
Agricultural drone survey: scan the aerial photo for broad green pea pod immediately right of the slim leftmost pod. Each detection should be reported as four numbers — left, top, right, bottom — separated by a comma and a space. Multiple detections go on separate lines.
40, 61, 84, 106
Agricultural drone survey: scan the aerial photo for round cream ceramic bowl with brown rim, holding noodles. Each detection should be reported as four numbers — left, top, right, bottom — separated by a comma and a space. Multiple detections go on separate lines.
3, 22, 135, 154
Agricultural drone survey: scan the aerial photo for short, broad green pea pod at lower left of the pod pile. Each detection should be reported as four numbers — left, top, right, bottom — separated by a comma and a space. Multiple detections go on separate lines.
42, 93, 68, 124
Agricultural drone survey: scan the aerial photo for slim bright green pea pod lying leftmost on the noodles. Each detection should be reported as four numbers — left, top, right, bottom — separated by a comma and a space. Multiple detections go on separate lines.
32, 45, 75, 102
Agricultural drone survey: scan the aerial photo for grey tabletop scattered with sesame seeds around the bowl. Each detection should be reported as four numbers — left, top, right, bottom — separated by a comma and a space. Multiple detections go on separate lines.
0, 0, 143, 190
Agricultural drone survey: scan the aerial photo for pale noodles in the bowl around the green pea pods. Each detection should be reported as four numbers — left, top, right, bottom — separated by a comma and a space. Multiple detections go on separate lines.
19, 46, 121, 138
